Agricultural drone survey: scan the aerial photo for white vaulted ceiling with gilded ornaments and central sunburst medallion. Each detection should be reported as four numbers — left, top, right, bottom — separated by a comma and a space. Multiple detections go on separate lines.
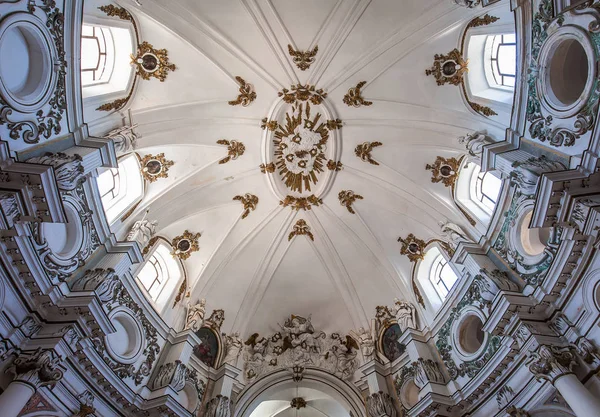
97, 0, 512, 336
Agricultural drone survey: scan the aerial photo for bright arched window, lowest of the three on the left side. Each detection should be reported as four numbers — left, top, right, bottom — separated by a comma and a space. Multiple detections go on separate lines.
137, 242, 182, 312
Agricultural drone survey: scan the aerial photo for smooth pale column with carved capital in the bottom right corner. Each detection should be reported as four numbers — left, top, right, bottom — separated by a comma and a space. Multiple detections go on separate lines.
529, 345, 600, 417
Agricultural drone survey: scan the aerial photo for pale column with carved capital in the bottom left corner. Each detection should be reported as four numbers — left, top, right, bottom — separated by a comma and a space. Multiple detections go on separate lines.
0, 348, 66, 417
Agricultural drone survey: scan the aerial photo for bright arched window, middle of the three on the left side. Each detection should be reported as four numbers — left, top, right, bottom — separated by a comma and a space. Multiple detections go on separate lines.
96, 154, 144, 223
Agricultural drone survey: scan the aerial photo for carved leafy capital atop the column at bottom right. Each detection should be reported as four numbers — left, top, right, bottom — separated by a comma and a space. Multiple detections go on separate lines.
529, 345, 576, 384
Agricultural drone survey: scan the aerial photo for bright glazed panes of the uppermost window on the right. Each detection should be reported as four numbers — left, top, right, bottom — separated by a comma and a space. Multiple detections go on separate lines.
484, 33, 517, 90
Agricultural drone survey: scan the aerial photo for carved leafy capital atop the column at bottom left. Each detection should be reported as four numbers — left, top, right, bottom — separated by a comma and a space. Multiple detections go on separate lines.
8, 348, 66, 390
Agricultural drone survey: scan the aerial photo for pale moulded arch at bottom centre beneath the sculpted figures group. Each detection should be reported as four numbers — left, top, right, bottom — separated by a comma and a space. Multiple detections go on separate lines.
233, 368, 366, 417
